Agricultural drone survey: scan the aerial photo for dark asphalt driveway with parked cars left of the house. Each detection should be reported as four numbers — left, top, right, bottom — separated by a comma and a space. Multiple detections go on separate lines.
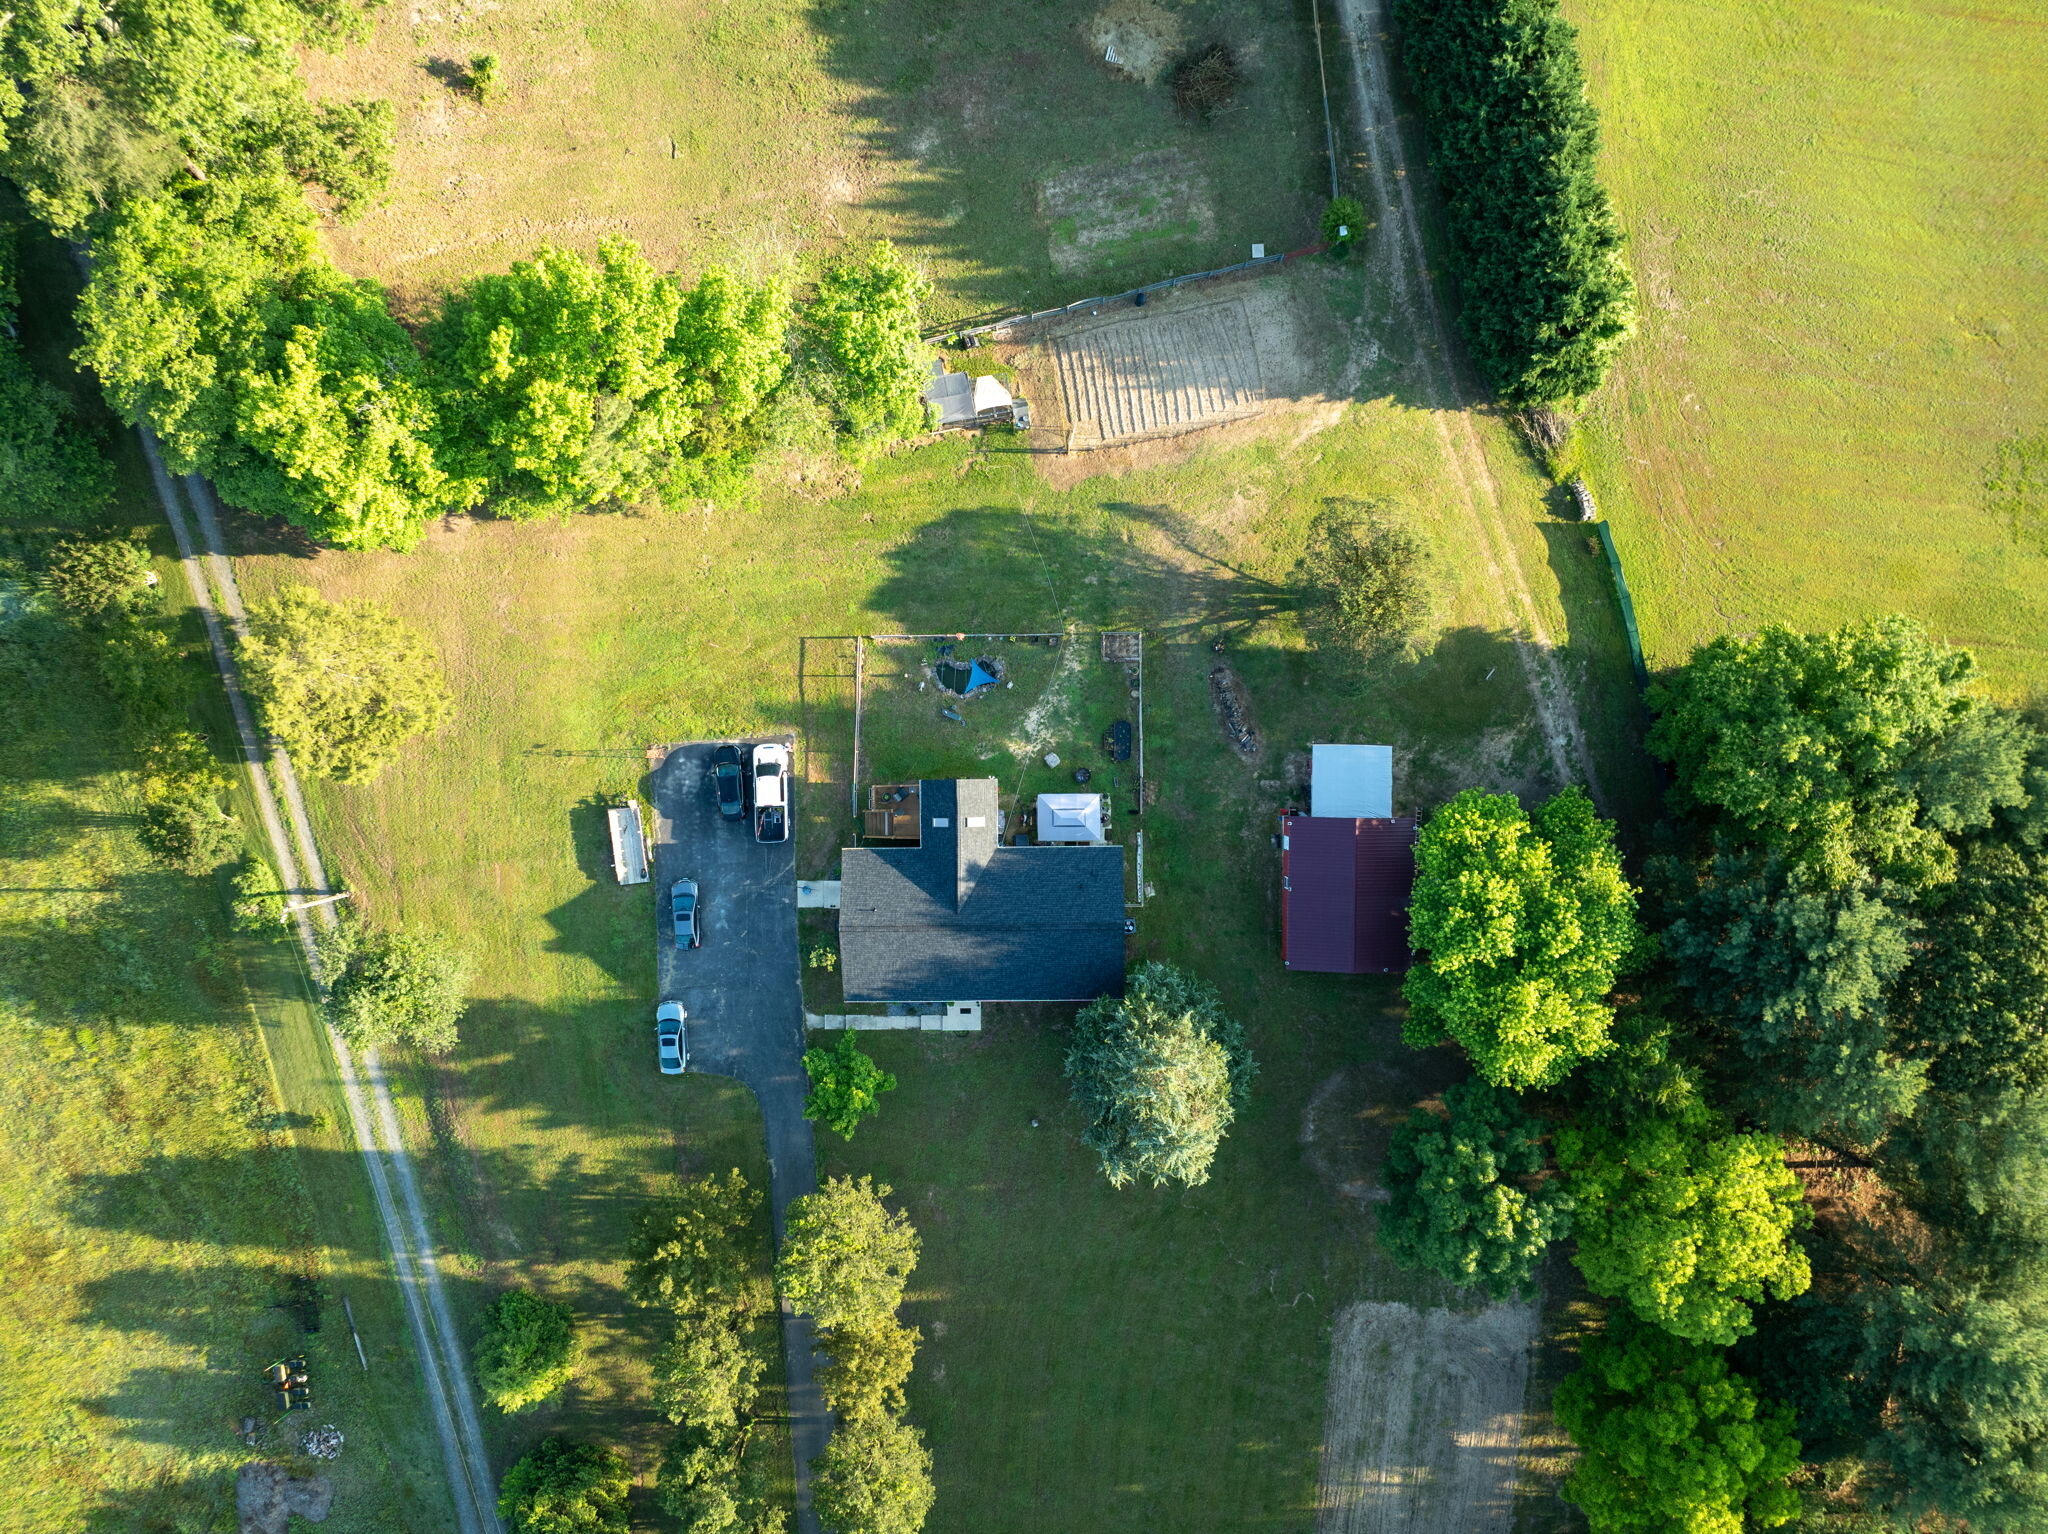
653, 743, 831, 1534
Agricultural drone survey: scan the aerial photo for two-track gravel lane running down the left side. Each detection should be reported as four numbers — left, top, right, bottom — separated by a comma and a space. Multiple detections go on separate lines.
141, 426, 504, 1534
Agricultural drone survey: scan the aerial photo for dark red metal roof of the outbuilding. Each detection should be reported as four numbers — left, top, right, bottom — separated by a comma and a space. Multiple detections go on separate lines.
1280, 815, 1415, 975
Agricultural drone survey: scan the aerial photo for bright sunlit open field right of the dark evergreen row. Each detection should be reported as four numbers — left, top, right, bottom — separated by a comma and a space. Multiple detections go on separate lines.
1565, 0, 2048, 696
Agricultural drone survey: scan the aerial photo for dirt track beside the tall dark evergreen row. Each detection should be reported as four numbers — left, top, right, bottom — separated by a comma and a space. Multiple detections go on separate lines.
1337, 0, 1599, 799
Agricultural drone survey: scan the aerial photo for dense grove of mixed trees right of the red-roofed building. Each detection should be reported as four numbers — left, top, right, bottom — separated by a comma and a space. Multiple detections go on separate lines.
1382, 619, 2048, 1534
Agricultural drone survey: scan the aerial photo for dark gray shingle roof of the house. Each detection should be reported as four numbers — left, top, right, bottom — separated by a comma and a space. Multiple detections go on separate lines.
840, 778, 1124, 1002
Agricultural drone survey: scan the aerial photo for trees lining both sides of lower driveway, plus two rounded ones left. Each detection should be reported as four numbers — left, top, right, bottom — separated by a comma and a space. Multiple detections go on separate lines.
491, 1169, 932, 1534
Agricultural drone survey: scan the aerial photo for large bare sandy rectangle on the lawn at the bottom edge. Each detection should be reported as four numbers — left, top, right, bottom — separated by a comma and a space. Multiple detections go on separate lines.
1315, 1303, 1536, 1534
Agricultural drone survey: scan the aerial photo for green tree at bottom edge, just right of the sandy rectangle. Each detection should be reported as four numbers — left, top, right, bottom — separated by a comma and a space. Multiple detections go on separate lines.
1554, 1315, 1800, 1534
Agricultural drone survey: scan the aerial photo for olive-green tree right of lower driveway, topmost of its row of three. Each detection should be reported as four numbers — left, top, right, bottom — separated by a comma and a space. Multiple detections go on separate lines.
774, 1178, 918, 1329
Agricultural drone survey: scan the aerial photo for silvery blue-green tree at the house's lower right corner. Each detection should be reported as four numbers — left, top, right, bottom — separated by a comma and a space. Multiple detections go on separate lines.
1067, 963, 1257, 1188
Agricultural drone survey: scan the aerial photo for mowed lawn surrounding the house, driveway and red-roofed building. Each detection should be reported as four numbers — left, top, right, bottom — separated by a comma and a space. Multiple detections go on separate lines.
224, 307, 1628, 1534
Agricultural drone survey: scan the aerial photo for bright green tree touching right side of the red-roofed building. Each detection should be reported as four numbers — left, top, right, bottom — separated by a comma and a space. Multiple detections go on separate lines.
1403, 789, 1642, 1090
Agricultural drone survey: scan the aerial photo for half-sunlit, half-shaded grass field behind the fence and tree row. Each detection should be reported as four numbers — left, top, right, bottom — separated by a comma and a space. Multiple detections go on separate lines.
307, 0, 1329, 317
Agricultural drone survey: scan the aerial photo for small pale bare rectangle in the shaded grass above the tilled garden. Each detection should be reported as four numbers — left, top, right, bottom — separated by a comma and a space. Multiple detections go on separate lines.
1038, 150, 1217, 272
